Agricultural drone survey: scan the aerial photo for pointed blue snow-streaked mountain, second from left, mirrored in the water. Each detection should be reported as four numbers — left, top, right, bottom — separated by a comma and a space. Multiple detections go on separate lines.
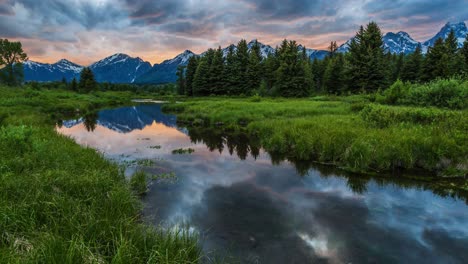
90, 53, 151, 83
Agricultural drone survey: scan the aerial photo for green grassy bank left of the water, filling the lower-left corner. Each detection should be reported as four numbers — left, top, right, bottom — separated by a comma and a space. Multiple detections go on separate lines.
0, 87, 200, 263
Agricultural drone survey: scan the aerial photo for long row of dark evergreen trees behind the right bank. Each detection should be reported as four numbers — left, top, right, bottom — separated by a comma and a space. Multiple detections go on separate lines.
177, 22, 468, 97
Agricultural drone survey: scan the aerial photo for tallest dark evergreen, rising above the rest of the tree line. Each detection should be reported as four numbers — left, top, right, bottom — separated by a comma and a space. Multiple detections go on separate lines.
348, 22, 386, 92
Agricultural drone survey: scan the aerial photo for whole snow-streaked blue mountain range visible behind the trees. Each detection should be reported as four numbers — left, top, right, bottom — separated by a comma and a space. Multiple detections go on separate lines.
24, 22, 468, 84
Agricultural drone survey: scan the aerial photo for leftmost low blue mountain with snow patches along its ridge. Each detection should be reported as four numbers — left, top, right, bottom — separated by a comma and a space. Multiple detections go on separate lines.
23, 59, 83, 82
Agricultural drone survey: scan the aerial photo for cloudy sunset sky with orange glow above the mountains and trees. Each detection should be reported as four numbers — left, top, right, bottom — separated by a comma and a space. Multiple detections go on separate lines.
0, 0, 468, 65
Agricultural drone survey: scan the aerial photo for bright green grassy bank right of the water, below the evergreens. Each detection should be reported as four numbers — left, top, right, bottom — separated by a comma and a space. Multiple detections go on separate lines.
165, 95, 468, 177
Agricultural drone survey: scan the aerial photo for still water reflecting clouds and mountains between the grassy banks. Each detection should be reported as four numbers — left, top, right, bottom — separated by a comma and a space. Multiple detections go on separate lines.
57, 104, 468, 263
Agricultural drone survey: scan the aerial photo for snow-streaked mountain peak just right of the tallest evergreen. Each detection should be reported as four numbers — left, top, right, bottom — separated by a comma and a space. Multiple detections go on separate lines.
383, 31, 420, 54
